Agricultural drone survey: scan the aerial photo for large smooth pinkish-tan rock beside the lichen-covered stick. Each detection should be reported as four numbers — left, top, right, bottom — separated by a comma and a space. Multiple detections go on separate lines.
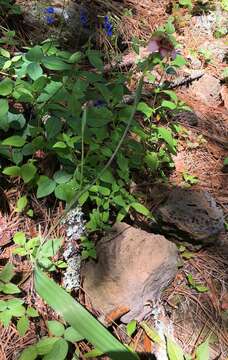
82, 223, 178, 322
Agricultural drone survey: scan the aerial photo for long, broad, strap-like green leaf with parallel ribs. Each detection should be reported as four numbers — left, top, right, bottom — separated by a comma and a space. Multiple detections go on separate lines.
35, 268, 138, 360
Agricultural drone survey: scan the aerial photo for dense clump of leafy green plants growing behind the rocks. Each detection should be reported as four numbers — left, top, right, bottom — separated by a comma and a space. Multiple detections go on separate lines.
0, 41, 184, 231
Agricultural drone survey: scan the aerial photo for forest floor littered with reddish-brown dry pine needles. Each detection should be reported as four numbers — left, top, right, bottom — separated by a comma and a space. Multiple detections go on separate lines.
0, 1, 228, 360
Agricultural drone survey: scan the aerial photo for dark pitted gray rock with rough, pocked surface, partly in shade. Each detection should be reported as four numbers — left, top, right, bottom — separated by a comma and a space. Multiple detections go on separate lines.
155, 188, 224, 244
